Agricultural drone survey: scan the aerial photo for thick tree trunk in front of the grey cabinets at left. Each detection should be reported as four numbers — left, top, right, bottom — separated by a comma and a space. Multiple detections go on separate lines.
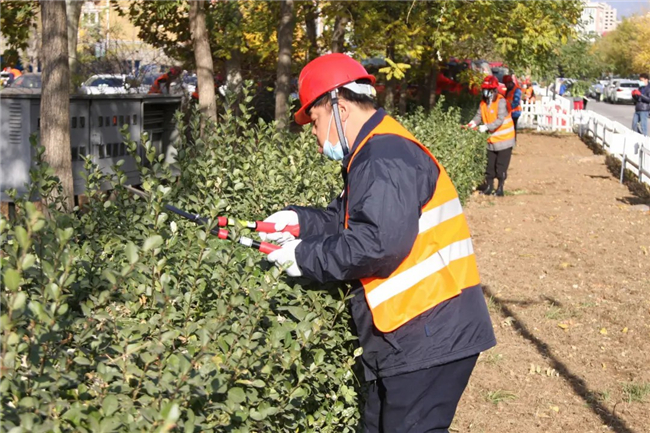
40, 0, 74, 211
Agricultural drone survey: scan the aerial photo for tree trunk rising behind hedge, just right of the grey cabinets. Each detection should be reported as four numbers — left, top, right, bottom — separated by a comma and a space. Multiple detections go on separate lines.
190, 0, 217, 125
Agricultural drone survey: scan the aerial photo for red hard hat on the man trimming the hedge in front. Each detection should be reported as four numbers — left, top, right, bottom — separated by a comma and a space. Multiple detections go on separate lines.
295, 53, 375, 125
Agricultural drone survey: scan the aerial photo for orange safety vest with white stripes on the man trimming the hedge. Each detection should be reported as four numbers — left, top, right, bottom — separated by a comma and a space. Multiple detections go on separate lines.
345, 116, 480, 332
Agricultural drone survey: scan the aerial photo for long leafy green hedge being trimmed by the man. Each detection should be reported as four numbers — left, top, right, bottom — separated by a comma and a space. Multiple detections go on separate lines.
0, 98, 485, 432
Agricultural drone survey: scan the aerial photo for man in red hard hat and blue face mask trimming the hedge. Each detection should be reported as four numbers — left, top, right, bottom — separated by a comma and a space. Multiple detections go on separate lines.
258, 54, 495, 433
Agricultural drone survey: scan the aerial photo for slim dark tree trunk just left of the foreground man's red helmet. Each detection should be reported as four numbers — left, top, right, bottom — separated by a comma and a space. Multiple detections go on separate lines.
275, 0, 295, 129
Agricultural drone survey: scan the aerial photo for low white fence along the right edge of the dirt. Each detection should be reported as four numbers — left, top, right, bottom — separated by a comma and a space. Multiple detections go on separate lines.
517, 91, 650, 184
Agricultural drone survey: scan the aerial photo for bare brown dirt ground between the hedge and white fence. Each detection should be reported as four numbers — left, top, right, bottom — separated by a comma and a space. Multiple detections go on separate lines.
451, 134, 650, 433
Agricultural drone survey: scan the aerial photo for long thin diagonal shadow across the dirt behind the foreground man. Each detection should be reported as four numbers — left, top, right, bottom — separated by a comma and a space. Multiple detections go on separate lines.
483, 286, 635, 433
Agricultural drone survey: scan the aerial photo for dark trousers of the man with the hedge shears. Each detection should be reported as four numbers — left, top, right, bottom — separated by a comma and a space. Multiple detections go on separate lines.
363, 355, 478, 433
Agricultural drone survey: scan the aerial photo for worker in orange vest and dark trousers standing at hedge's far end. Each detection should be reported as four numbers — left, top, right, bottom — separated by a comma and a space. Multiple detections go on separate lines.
466, 75, 515, 197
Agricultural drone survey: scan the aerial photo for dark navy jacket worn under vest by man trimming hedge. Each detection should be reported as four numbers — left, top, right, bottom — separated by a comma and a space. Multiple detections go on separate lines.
289, 110, 496, 380
